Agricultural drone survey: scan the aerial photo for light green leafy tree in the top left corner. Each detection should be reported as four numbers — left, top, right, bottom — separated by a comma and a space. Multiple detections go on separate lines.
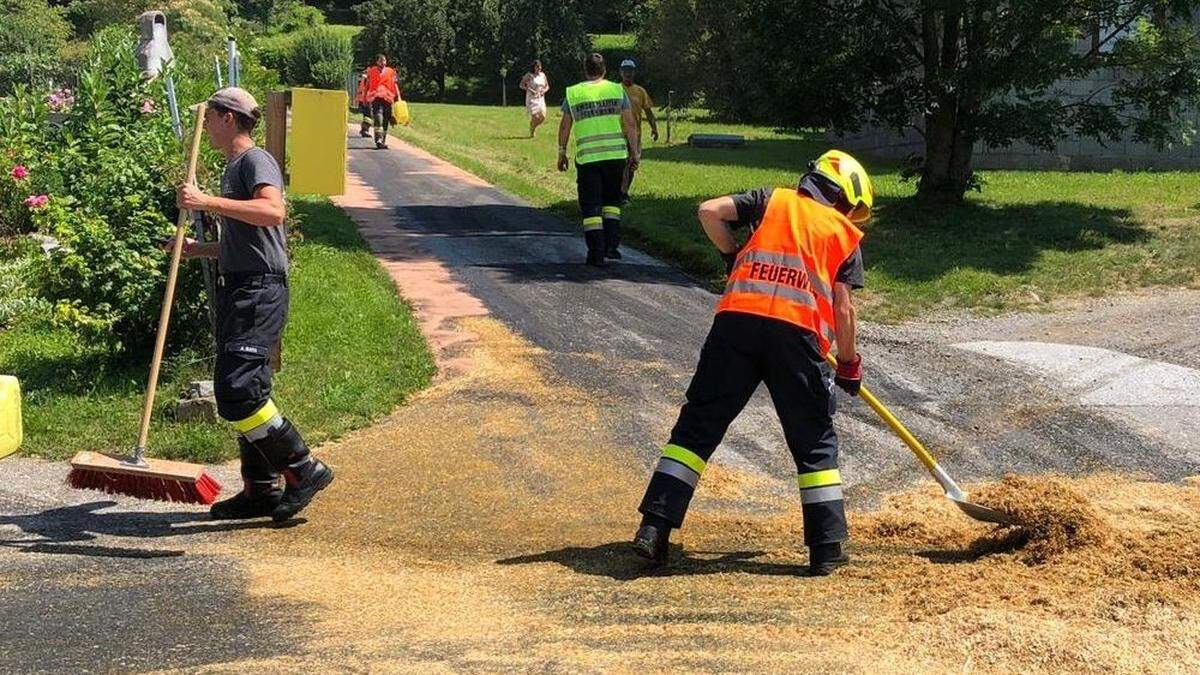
0, 0, 71, 94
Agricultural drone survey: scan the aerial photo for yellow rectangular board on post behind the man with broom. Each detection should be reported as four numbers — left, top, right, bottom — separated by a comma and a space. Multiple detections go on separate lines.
288, 89, 348, 195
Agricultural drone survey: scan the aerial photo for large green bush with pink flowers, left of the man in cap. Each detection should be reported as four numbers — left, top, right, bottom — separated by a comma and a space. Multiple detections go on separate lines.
0, 28, 211, 354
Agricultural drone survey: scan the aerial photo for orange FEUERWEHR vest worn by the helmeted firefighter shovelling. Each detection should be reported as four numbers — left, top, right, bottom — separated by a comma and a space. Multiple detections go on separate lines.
716, 187, 863, 354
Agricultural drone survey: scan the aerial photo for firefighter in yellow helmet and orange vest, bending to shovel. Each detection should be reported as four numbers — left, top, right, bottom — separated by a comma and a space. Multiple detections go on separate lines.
634, 150, 875, 575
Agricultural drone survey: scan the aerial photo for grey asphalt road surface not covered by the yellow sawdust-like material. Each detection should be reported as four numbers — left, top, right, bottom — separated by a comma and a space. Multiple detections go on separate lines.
0, 137, 1200, 673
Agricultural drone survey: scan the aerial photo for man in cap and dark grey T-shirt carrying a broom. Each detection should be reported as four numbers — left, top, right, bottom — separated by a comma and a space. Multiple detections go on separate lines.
168, 86, 334, 522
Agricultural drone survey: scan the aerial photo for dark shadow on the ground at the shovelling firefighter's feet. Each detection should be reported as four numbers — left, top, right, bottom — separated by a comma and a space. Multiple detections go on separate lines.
496, 542, 809, 581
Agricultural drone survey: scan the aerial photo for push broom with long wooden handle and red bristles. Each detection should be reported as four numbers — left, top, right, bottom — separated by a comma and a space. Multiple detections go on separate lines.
67, 103, 221, 504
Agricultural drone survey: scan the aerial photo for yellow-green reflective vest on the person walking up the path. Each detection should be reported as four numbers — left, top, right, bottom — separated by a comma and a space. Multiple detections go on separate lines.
566, 79, 629, 165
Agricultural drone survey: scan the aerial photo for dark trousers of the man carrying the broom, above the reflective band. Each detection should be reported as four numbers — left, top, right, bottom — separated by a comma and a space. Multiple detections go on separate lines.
212, 274, 288, 423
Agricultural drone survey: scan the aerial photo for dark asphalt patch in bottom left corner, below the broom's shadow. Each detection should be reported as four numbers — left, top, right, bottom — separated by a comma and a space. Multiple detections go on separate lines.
0, 544, 307, 673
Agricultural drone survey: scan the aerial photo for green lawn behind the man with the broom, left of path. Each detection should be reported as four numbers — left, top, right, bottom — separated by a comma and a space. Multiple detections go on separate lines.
0, 199, 433, 462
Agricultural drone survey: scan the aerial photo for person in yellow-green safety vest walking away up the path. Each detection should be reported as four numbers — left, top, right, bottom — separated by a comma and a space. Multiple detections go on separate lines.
558, 54, 641, 267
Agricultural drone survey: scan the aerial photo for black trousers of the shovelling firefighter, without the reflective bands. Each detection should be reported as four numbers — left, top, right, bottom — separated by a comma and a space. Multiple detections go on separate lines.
638, 312, 847, 546
